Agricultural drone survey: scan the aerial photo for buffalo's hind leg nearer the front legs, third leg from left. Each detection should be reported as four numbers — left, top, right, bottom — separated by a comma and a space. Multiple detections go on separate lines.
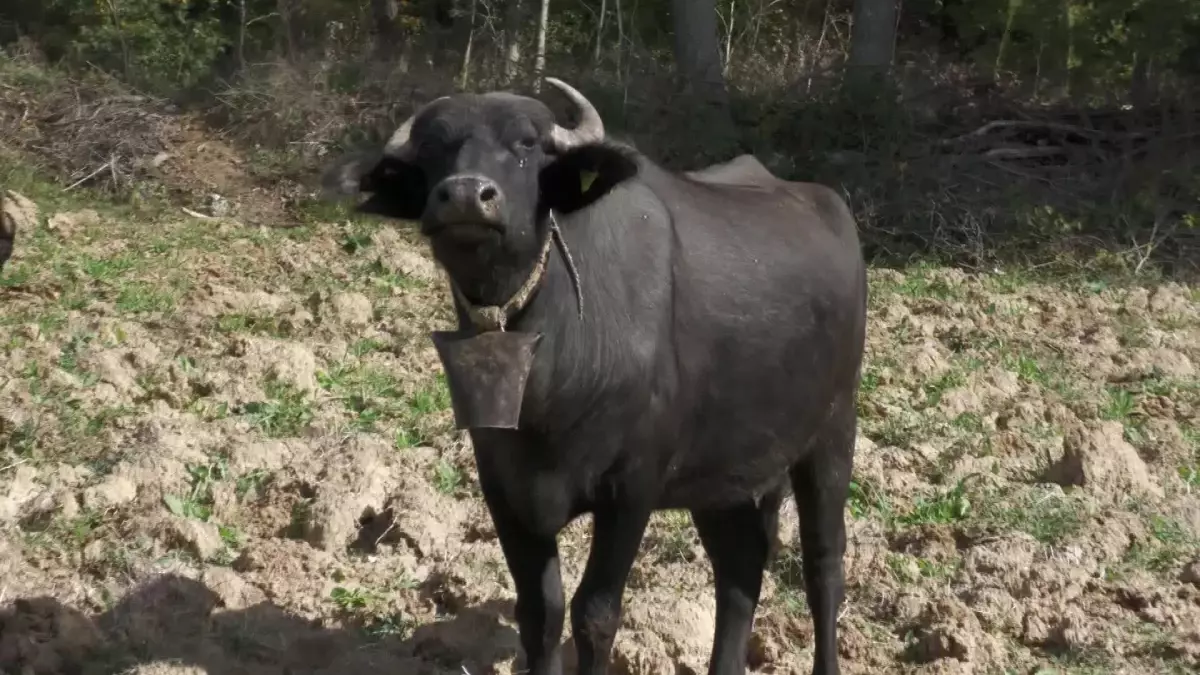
691, 486, 784, 675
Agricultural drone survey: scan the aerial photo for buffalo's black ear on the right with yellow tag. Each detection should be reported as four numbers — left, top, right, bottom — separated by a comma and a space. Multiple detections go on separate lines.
540, 144, 637, 214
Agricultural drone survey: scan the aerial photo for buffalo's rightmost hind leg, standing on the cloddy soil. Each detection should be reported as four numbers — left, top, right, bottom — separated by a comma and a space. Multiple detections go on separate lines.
791, 407, 856, 675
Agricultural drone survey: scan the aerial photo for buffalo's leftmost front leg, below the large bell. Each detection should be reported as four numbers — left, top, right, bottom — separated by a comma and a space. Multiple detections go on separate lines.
481, 474, 566, 675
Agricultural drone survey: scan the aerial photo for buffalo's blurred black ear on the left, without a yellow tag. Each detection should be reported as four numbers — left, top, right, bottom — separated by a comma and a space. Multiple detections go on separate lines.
322, 153, 428, 220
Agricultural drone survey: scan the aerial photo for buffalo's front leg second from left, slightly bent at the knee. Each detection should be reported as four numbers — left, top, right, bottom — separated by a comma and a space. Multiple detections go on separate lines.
571, 506, 650, 675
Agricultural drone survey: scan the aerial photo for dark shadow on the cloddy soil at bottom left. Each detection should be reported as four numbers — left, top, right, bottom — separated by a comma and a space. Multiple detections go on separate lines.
0, 574, 518, 675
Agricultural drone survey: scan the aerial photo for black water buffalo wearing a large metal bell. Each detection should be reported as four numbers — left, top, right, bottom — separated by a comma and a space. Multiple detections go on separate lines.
325, 78, 866, 675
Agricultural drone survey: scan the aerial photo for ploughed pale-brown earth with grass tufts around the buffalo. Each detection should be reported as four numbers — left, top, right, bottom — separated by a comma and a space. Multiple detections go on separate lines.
0, 158, 1200, 675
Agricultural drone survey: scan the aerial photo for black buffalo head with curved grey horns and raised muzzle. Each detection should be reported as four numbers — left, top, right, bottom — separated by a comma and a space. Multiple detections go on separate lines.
325, 78, 637, 307
